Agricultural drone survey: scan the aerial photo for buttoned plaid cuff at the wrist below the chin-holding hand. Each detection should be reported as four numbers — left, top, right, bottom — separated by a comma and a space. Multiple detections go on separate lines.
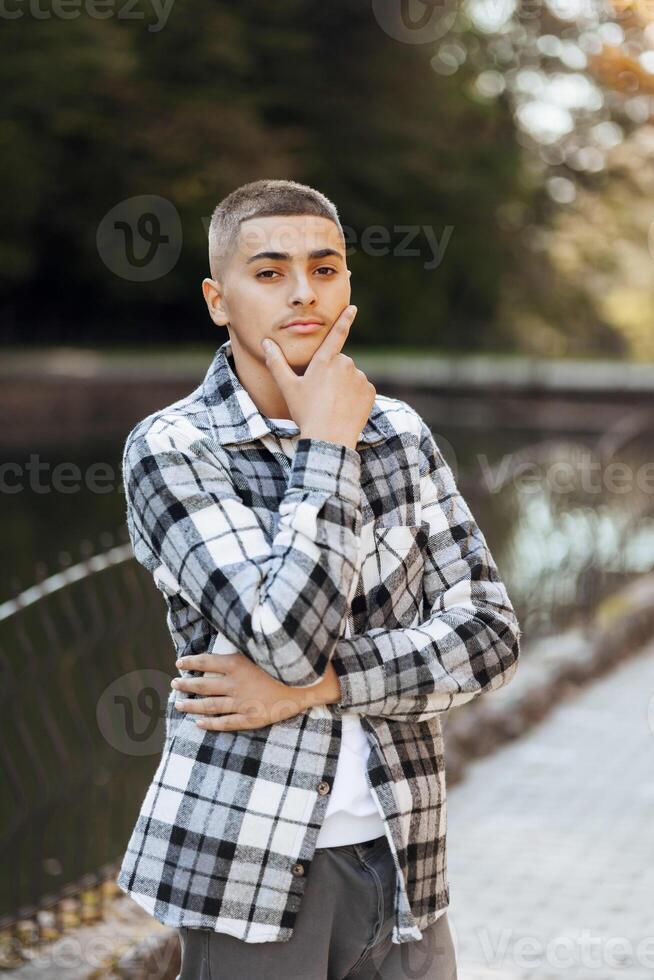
288, 438, 361, 504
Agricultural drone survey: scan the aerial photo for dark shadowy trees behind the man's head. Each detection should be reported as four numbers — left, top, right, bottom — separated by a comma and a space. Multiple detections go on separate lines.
0, 0, 519, 348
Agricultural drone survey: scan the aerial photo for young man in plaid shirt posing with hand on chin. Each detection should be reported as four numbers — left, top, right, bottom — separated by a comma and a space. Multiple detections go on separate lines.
118, 180, 520, 980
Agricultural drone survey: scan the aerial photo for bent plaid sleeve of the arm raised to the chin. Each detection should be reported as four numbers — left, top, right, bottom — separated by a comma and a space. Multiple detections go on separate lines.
122, 426, 361, 686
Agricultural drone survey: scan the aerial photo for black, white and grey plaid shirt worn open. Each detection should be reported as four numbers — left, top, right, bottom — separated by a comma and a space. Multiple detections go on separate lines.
117, 340, 520, 943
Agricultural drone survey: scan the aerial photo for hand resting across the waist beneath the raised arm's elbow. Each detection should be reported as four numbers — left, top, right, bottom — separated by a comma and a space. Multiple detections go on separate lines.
171, 653, 313, 732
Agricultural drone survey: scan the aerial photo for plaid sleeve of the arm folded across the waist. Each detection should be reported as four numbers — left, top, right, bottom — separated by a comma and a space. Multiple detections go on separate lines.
329, 419, 521, 721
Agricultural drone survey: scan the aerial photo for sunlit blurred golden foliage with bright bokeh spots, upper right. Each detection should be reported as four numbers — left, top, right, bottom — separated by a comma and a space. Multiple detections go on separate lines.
458, 0, 654, 360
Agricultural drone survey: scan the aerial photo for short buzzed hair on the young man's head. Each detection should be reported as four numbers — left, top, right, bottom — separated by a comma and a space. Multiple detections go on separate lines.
209, 180, 345, 279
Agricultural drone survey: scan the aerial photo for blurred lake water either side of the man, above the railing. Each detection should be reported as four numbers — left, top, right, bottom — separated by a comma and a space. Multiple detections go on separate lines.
0, 426, 654, 632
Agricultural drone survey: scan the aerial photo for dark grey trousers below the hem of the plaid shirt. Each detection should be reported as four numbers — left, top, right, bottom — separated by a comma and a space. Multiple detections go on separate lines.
176, 837, 457, 980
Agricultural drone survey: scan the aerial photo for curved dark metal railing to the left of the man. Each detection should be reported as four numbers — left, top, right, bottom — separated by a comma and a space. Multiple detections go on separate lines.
0, 528, 175, 964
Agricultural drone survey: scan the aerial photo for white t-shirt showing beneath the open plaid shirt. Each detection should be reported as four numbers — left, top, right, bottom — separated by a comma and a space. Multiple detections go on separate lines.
270, 419, 386, 847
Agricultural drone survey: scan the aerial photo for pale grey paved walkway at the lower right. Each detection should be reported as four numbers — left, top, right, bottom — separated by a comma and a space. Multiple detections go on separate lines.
446, 644, 654, 980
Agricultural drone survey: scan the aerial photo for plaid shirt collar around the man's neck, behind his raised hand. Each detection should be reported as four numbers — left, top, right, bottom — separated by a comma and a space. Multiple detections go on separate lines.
201, 338, 394, 445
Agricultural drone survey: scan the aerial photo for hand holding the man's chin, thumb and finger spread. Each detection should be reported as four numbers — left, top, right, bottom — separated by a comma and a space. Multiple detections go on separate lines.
264, 306, 377, 449
